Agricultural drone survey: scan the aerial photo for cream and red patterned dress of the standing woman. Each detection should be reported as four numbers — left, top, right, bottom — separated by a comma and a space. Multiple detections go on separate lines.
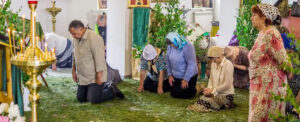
248, 27, 287, 122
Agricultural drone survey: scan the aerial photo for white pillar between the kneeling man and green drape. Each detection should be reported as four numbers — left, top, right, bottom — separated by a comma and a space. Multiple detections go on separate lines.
107, 0, 127, 76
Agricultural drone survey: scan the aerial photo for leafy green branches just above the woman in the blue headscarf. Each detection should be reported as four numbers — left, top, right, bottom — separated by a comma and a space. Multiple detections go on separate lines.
148, 0, 192, 51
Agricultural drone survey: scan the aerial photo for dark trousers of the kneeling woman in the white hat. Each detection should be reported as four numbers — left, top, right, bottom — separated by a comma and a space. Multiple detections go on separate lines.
144, 76, 171, 92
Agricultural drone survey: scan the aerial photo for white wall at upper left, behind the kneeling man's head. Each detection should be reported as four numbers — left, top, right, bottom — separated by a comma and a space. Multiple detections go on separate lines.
11, 0, 98, 39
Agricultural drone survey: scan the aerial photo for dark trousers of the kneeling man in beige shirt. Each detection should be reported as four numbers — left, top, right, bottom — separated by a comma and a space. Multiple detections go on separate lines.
77, 82, 116, 104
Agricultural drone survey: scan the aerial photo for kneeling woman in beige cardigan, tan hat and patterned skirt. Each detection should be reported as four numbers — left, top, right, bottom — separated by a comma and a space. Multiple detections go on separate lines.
188, 46, 234, 112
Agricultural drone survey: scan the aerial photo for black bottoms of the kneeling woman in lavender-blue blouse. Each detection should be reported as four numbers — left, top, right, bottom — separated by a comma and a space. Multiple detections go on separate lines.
171, 75, 197, 99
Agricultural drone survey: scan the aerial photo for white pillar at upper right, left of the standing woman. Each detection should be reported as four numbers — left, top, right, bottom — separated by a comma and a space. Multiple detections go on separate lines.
216, 0, 240, 47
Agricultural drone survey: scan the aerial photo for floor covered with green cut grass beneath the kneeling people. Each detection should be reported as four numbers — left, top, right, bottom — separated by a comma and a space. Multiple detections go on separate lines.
25, 77, 249, 122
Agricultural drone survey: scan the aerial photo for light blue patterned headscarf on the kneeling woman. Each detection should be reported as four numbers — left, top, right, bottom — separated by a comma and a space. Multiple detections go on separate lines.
166, 32, 187, 49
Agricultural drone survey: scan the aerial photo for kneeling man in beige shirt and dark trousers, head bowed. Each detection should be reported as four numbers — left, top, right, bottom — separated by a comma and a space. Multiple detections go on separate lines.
69, 20, 124, 104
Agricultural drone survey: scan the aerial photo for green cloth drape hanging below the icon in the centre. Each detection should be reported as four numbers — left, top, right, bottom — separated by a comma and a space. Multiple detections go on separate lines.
132, 8, 150, 47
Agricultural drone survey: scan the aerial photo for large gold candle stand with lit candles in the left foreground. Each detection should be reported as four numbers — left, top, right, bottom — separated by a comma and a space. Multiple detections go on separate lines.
11, 0, 56, 122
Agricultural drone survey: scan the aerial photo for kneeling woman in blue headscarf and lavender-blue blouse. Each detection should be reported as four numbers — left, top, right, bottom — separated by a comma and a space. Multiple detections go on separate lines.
166, 32, 198, 99
